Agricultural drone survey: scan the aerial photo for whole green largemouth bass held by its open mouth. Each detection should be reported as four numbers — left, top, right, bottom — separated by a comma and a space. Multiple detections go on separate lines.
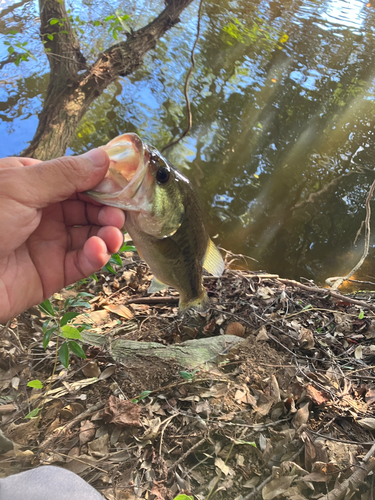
85, 133, 225, 312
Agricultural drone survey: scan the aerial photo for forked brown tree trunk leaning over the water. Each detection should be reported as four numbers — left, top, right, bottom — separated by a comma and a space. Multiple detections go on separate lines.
22, 0, 192, 160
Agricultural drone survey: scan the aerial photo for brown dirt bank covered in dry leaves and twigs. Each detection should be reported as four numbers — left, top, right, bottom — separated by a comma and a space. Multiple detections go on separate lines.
0, 253, 375, 500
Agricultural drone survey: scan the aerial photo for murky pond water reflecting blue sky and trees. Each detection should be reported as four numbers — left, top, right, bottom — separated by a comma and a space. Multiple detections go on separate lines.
0, 0, 375, 283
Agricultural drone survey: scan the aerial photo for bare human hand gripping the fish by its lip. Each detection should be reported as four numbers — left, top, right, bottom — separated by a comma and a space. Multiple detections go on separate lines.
0, 149, 125, 323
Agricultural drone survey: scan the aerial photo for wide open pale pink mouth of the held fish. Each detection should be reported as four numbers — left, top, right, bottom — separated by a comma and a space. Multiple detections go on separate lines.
85, 133, 149, 211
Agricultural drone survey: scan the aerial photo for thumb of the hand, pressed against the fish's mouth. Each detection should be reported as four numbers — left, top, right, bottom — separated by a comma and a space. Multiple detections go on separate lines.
13, 149, 109, 208
